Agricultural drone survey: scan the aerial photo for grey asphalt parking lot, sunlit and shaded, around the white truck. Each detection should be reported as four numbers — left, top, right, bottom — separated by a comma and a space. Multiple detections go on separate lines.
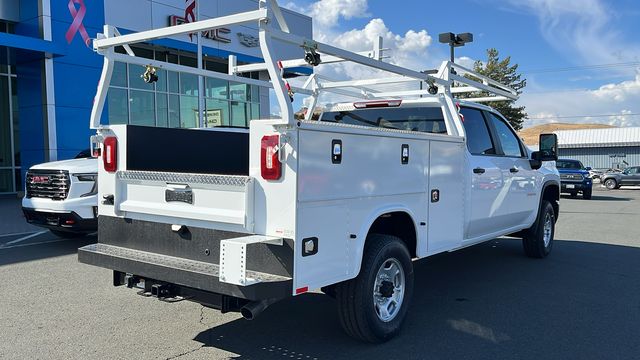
0, 189, 640, 359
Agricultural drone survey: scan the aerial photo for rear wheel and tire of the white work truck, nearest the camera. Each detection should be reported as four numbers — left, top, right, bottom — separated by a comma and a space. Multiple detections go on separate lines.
336, 234, 413, 343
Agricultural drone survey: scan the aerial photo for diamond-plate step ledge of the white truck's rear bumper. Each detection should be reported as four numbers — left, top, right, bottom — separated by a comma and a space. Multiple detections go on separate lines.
78, 243, 292, 301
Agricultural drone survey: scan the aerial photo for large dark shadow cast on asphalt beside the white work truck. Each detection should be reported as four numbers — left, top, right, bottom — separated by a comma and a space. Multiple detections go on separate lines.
195, 239, 640, 359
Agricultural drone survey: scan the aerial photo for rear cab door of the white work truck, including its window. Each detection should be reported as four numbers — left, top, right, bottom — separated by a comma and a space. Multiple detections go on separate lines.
460, 107, 508, 239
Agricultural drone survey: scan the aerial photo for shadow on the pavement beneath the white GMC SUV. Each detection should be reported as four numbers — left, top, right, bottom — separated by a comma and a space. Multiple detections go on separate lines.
0, 233, 97, 266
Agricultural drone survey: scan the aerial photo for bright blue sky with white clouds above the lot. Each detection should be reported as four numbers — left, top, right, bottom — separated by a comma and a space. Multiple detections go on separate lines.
281, 0, 640, 126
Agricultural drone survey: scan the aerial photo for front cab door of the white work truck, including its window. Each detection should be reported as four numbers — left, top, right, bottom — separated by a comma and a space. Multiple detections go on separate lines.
485, 111, 541, 227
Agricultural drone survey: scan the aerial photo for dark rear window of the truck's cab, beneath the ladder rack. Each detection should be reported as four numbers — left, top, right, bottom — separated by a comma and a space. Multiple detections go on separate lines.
320, 107, 447, 134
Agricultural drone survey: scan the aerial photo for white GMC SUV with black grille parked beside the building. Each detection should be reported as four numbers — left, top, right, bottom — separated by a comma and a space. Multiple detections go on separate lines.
22, 150, 98, 238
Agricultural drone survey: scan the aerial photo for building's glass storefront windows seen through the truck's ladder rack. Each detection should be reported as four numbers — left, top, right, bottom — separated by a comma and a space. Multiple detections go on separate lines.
107, 47, 260, 128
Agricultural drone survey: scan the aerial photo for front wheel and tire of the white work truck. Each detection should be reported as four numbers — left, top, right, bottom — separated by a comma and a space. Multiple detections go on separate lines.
522, 200, 556, 259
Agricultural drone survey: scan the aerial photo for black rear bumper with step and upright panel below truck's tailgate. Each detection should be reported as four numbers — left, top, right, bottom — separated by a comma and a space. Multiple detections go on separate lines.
78, 216, 293, 301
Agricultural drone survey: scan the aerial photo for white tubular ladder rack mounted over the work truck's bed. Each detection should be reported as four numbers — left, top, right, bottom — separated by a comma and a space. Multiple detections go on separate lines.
90, 0, 518, 135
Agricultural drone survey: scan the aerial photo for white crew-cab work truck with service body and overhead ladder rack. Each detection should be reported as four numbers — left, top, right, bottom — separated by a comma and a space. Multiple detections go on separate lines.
78, 0, 560, 342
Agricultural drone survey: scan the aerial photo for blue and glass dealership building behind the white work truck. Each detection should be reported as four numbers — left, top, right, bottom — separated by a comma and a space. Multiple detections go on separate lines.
0, 0, 312, 194
